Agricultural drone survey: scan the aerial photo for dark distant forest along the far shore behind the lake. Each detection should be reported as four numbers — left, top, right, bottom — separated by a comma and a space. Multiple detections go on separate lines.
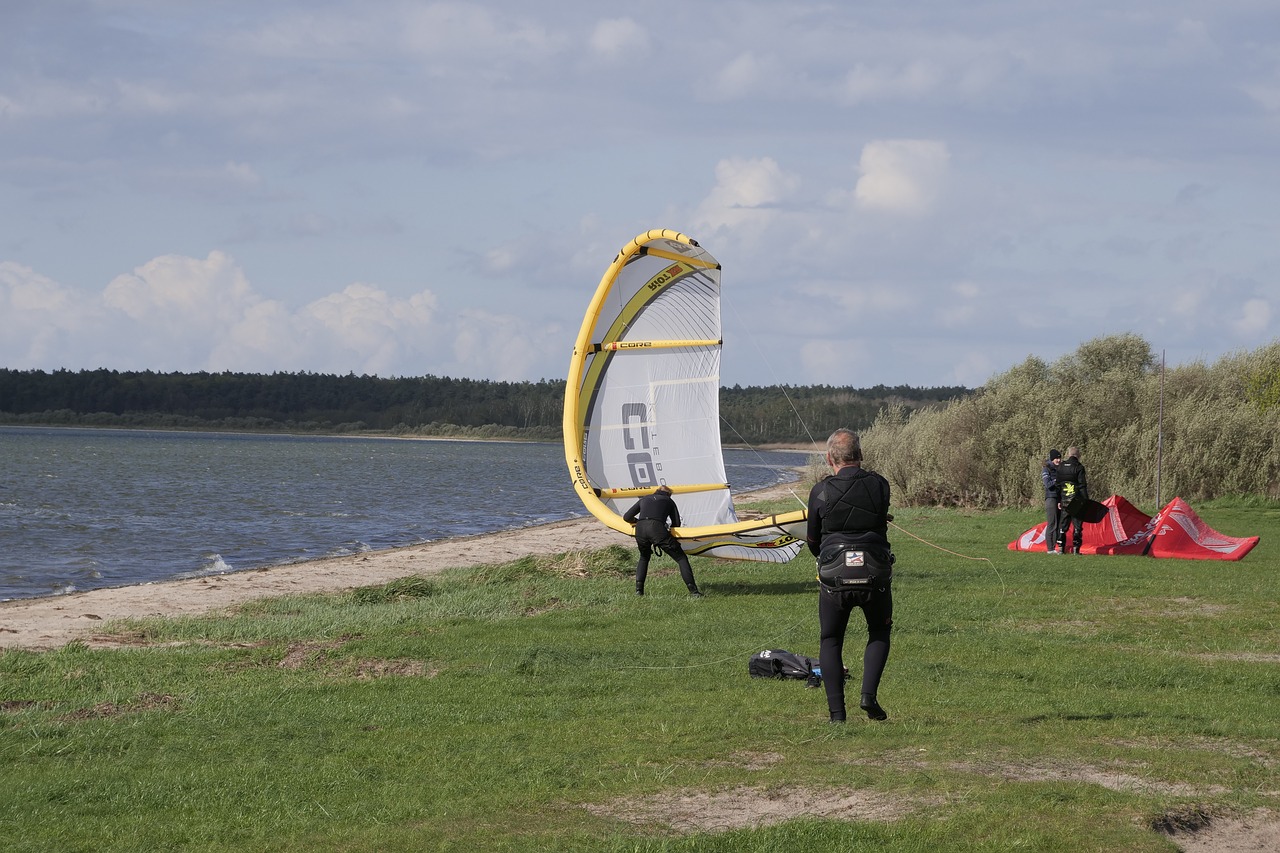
0, 369, 970, 446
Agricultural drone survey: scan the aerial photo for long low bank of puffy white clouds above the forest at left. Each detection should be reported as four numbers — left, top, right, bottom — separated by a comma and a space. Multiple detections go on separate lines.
0, 251, 471, 375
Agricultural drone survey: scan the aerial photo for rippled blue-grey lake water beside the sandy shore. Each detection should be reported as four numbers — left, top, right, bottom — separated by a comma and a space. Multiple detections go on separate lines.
0, 427, 808, 601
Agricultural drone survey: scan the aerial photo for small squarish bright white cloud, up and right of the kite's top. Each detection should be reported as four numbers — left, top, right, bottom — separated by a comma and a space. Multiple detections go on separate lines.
854, 140, 951, 214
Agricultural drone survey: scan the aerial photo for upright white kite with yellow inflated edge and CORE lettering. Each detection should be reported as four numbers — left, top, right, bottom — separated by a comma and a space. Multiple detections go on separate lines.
564, 229, 805, 562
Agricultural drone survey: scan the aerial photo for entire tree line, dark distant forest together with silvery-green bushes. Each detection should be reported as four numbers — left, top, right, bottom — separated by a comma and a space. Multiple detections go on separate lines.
0, 334, 1280, 510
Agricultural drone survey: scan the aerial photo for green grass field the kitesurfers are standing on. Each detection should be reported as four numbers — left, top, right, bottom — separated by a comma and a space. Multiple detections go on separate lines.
0, 502, 1280, 853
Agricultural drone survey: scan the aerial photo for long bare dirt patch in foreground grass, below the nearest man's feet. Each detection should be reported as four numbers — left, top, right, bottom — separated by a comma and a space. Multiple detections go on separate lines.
586, 786, 927, 833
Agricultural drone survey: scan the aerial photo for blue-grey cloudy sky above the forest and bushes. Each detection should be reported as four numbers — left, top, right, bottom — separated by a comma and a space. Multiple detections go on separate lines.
0, 0, 1280, 387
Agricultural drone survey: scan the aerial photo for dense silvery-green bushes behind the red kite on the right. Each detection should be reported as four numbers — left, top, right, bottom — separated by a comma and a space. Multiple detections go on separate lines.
863, 334, 1280, 507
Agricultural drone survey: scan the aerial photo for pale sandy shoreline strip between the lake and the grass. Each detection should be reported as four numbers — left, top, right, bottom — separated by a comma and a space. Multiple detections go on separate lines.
0, 481, 803, 651
